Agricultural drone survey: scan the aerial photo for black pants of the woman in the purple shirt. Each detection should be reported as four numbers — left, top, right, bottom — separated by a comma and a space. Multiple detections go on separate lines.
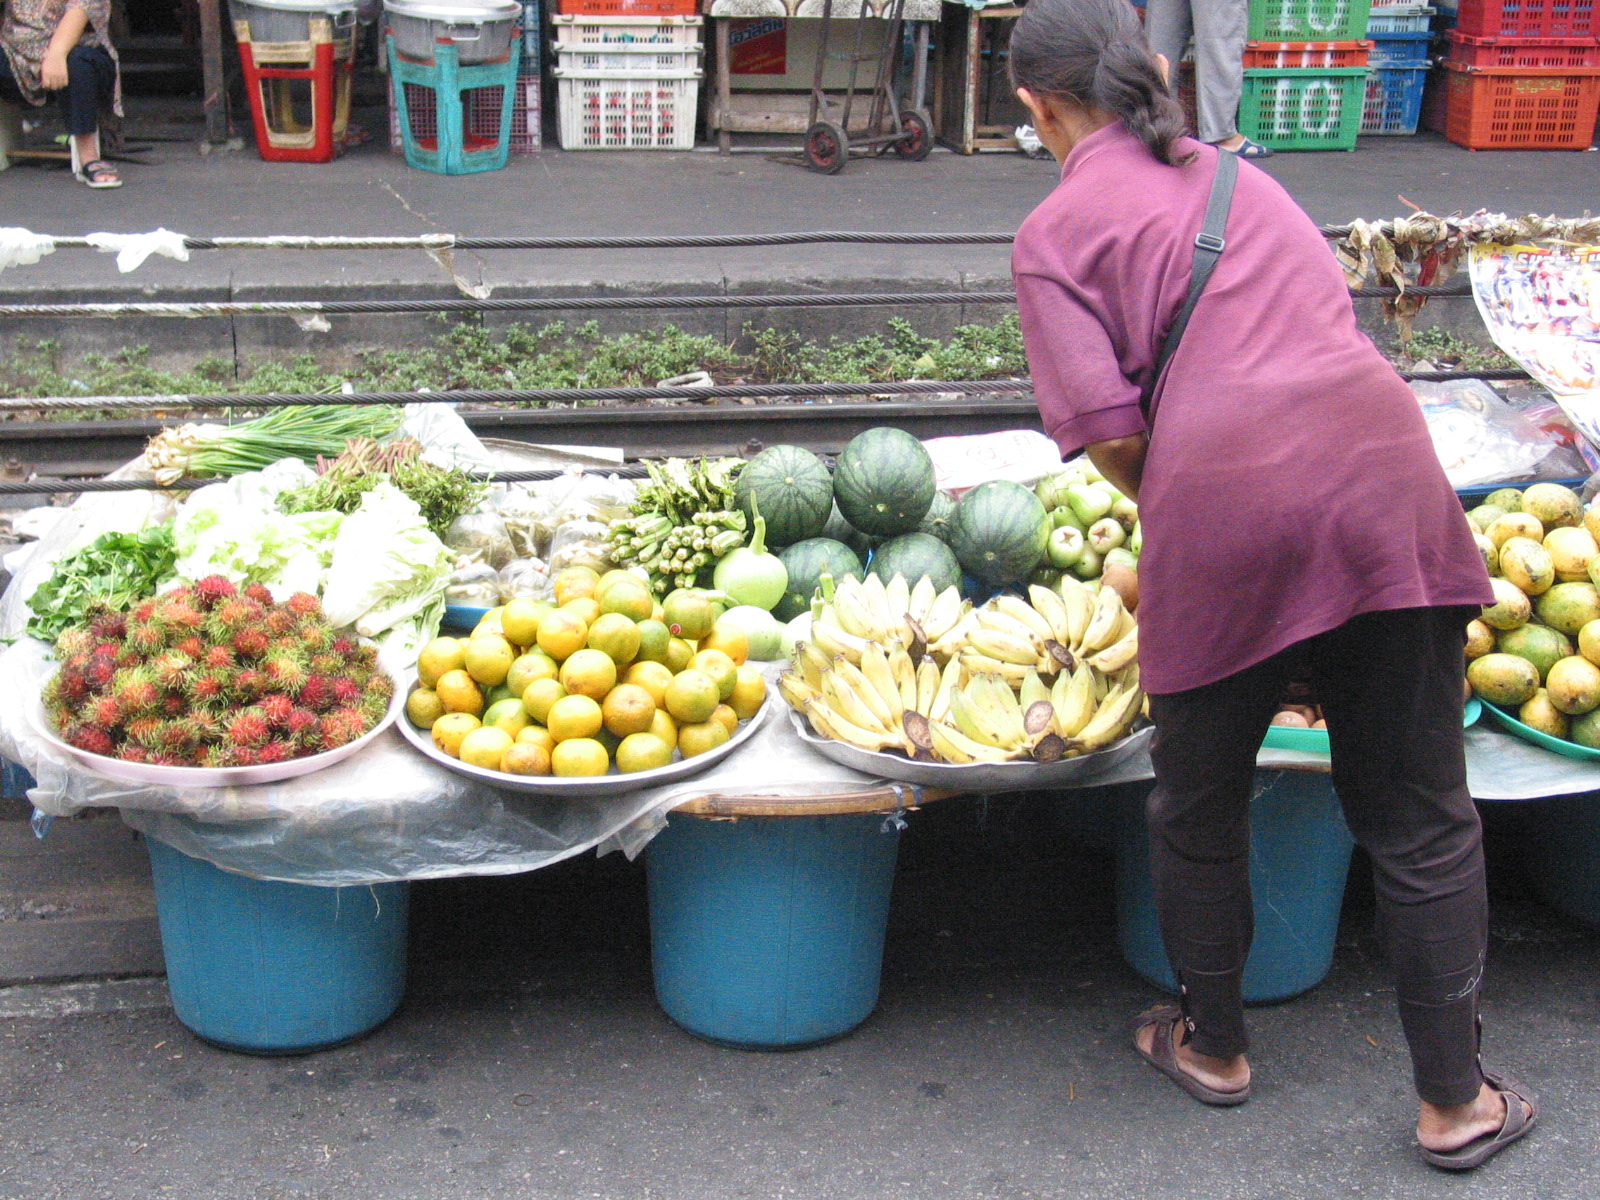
1147, 608, 1488, 1104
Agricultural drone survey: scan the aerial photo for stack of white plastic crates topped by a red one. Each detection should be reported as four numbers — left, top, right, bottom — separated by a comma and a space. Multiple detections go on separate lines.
554, 0, 706, 150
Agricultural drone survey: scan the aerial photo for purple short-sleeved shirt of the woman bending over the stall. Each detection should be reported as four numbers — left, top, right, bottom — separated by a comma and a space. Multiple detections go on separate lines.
1011, 122, 1493, 694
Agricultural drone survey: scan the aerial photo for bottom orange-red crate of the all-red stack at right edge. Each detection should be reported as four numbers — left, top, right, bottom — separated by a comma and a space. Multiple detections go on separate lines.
1445, 61, 1600, 150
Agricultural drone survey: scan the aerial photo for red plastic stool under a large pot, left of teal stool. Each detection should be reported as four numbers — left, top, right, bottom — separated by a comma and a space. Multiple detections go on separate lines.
234, 16, 355, 163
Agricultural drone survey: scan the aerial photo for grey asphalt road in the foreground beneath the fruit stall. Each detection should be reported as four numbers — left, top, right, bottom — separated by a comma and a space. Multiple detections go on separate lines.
0, 800, 1600, 1200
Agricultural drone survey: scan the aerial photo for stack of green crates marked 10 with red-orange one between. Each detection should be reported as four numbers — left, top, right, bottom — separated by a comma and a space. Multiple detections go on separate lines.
1238, 0, 1373, 150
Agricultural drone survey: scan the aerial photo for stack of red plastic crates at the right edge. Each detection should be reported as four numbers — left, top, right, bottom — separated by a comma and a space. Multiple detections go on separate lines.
1435, 0, 1600, 150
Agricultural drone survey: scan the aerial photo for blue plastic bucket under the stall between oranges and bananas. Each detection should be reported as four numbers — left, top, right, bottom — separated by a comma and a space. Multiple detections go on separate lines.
648, 814, 899, 1050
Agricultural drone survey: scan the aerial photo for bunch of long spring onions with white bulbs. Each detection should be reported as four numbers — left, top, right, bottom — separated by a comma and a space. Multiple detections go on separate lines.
144, 405, 402, 483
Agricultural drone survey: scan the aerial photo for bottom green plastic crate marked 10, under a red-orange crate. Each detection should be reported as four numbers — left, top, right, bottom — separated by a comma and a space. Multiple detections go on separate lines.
1238, 67, 1366, 150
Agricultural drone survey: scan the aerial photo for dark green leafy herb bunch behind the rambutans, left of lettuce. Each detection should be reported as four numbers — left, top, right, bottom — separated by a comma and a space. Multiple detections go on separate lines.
27, 523, 178, 642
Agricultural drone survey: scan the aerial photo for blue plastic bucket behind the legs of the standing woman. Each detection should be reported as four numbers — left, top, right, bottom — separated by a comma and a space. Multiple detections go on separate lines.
1117, 771, 1354, 1003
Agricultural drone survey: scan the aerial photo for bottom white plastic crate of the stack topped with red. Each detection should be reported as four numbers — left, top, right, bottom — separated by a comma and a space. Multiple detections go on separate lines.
555, 66, 704, 150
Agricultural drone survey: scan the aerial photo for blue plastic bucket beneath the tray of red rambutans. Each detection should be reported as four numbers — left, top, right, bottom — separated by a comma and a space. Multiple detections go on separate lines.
144, 838, 410, 1054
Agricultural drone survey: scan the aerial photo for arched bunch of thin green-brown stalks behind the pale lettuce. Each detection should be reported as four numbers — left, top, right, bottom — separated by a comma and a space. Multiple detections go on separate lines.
282, 437, 490, 538
